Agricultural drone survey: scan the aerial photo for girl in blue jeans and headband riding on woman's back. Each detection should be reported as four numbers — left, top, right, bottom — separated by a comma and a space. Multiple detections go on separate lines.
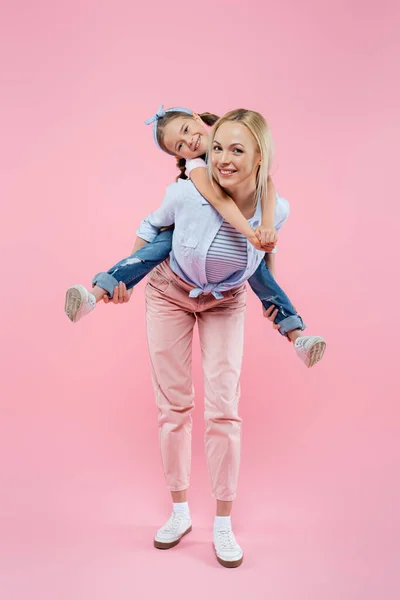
65, 107, 326, 367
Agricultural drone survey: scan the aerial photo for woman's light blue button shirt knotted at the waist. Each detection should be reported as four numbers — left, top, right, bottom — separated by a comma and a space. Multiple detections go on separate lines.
137, 179, 289, 299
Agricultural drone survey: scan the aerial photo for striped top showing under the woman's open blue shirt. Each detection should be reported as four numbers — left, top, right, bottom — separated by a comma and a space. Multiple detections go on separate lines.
206, 221, 247, 283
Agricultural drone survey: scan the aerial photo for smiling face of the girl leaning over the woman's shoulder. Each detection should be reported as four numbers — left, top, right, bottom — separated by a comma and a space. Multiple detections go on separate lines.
163, 115, 208, 159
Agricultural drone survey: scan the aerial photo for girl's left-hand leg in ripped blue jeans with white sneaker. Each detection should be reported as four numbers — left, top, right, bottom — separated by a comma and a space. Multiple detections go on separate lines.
65, 229, 173, 323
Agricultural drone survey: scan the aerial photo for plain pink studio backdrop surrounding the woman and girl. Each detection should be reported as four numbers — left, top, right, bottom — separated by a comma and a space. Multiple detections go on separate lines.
0, 0, 400, 600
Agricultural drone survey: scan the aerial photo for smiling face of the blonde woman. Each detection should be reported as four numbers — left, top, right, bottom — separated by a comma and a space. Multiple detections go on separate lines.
211, 121, 261, 189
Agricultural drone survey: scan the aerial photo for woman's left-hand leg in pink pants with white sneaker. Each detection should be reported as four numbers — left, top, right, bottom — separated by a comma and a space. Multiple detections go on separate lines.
146, 269, 195, 549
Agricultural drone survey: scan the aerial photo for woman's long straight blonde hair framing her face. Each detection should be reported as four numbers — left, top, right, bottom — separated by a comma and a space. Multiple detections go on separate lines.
208, 108, 274, 205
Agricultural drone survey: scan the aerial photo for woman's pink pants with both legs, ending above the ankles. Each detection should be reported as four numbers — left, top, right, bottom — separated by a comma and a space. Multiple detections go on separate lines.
146, 261, 246, 500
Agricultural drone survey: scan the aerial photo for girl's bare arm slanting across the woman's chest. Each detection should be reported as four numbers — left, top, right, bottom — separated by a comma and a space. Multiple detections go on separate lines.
190, 163, 260, 248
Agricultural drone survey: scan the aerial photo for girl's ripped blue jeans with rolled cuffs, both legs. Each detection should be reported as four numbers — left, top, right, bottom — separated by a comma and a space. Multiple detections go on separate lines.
92, 229, 305, 335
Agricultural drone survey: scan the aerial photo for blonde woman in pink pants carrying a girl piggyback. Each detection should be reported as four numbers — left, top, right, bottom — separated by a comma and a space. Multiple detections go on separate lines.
135, 109, 282, 567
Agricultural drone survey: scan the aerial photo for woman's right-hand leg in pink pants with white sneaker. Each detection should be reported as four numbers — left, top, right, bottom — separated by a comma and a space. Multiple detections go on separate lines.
198, 288, 246, 567
